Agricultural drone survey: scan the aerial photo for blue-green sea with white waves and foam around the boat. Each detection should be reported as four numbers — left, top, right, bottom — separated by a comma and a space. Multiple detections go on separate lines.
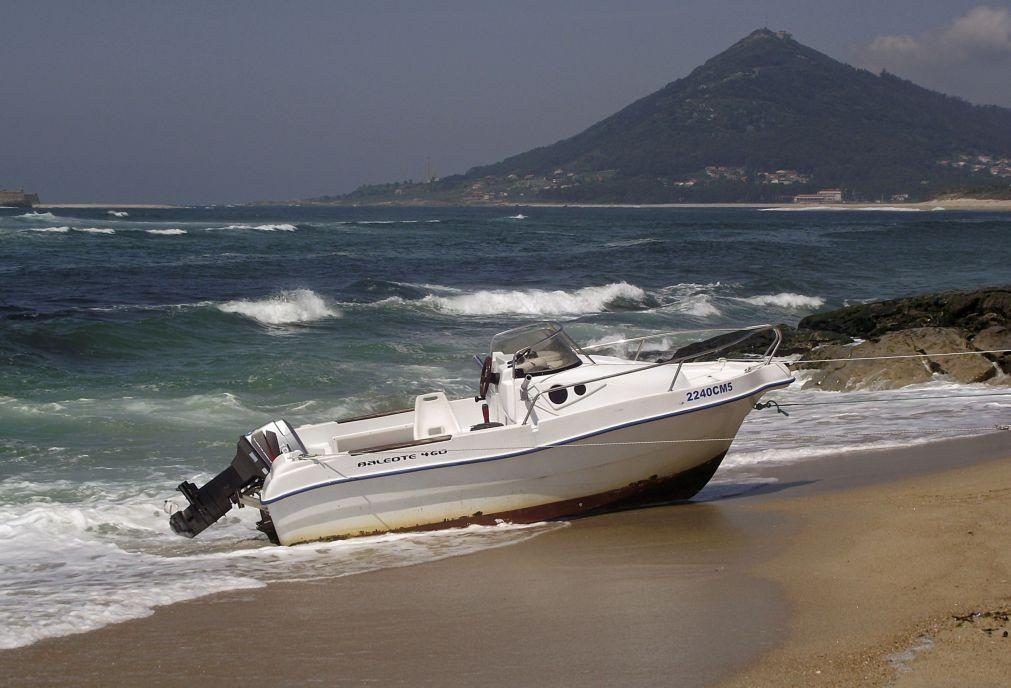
0, 207, 1011, 649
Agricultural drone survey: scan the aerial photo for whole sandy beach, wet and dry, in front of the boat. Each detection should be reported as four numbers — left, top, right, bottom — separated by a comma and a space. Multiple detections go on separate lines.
0, 432, 1011, 686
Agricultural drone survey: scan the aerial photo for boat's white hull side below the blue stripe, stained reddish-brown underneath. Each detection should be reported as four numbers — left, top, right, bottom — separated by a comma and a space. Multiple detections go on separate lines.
267, 383, 761, 545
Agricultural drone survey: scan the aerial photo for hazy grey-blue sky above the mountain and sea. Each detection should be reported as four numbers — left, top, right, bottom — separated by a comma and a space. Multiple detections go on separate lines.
0, 0, 1011, 202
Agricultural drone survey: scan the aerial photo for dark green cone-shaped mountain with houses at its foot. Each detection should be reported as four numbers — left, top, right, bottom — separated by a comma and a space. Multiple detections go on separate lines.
321, 29, 1011, 203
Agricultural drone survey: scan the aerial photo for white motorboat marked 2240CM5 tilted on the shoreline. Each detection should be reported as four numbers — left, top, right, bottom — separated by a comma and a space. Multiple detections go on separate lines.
170, 322, 794, 545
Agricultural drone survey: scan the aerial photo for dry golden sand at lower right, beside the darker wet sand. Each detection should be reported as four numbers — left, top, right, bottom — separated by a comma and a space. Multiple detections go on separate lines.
720, 432, 1011, 688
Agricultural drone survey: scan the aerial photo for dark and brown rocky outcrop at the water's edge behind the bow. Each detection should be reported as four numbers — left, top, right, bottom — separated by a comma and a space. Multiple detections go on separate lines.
785, 288, 1011, 391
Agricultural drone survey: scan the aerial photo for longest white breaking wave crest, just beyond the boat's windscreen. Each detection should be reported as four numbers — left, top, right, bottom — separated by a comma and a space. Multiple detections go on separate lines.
422, 282, 648, 315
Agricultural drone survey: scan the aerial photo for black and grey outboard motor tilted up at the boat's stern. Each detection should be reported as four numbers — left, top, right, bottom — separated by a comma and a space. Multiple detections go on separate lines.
169, 420, 307, 543
